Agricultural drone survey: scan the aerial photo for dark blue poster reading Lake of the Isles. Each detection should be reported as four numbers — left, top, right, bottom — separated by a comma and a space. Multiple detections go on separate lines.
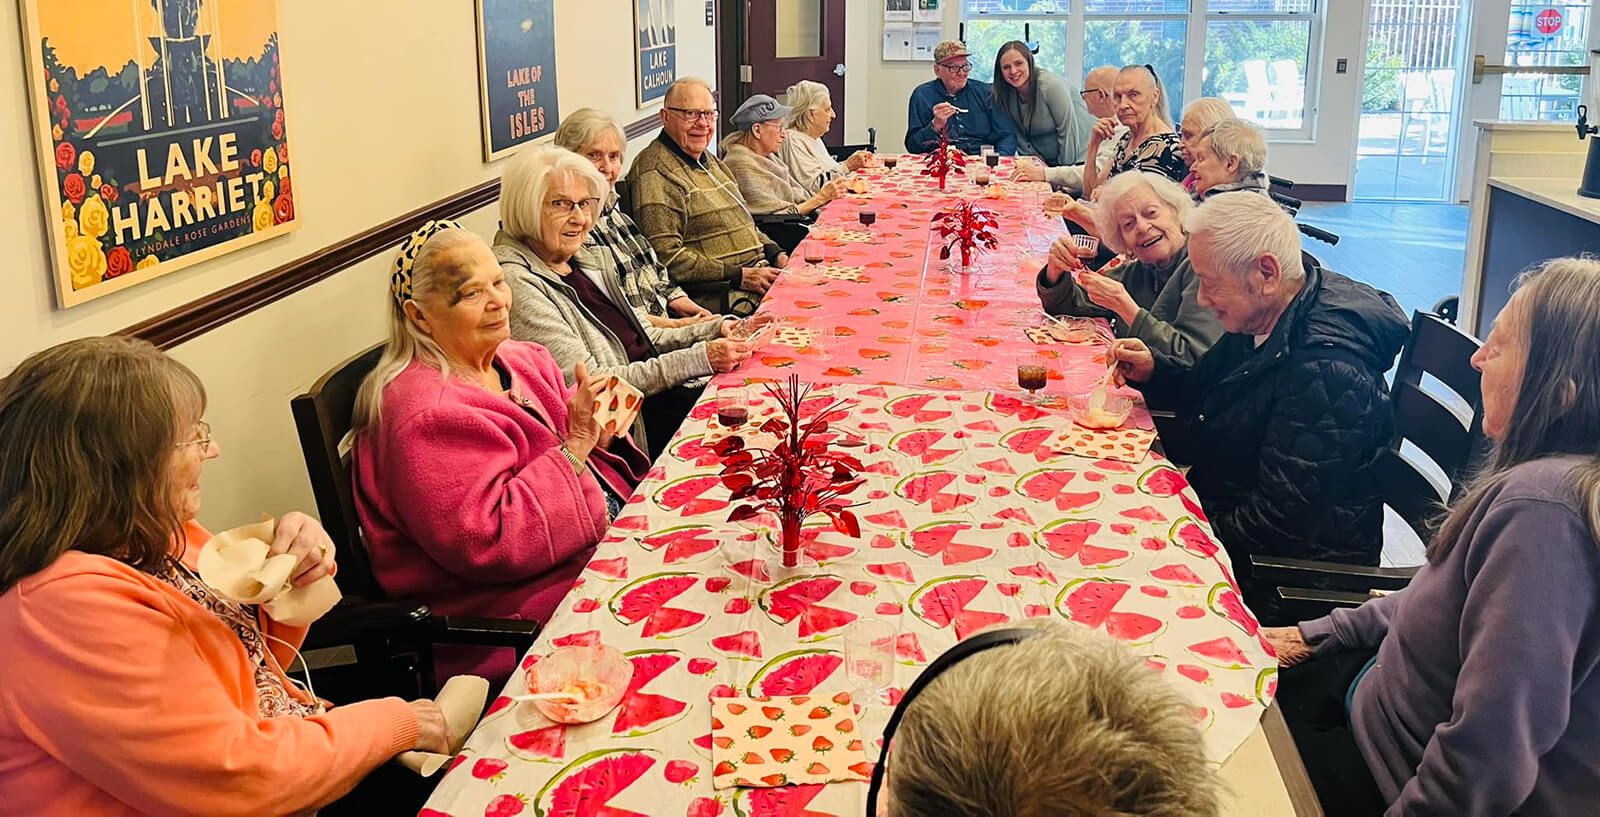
477, 0, 562, 161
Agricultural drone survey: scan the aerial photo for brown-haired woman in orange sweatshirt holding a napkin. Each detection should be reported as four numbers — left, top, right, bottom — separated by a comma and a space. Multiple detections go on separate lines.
0, 337, 450, 817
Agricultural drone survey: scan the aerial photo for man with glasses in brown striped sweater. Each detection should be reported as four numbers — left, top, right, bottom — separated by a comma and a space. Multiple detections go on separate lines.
627, 77, 789, 312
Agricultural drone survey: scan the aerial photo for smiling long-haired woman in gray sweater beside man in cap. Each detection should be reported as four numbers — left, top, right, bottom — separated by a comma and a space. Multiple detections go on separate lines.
990, 40, 1094, 168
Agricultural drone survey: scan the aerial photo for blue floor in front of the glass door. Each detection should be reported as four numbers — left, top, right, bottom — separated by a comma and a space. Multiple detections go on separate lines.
1299, 201, 1467, 318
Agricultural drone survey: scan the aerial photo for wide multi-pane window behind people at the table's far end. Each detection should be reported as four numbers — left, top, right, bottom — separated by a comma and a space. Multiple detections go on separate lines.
962, 0, 1324, 139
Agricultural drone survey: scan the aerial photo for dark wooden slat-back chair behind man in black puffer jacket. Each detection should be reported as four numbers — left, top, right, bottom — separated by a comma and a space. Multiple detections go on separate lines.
1250, 312, 1488, 620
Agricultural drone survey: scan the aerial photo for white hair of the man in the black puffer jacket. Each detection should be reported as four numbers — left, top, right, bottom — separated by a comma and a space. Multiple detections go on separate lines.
1184, 192, 1306, 281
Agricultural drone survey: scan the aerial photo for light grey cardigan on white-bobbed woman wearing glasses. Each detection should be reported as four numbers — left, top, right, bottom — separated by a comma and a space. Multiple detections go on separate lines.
494, 230, 722, 446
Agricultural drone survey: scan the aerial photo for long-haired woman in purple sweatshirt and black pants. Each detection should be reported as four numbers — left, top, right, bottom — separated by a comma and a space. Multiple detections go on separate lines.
1264, 257, 1600, 817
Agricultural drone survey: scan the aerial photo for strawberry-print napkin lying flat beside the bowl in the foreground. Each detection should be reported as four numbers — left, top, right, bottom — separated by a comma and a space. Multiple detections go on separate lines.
710, 692, 872, 788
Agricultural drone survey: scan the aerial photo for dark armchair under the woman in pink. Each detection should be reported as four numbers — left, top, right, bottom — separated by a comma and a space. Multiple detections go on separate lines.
290, 344, 539, 695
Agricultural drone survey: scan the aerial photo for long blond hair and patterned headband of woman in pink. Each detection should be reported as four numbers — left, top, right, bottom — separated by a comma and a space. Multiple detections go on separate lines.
350, 227, 483, 432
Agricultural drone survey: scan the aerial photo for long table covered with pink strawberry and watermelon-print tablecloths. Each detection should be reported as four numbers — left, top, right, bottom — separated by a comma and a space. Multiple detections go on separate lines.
422, 157, 1320, 817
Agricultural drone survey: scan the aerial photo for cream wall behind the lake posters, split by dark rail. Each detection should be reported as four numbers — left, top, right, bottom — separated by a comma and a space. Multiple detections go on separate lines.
0, 0, 715, 528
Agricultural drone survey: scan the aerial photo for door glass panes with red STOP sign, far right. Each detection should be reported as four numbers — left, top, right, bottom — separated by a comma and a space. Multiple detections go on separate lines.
1501, 0, 1590, 122
